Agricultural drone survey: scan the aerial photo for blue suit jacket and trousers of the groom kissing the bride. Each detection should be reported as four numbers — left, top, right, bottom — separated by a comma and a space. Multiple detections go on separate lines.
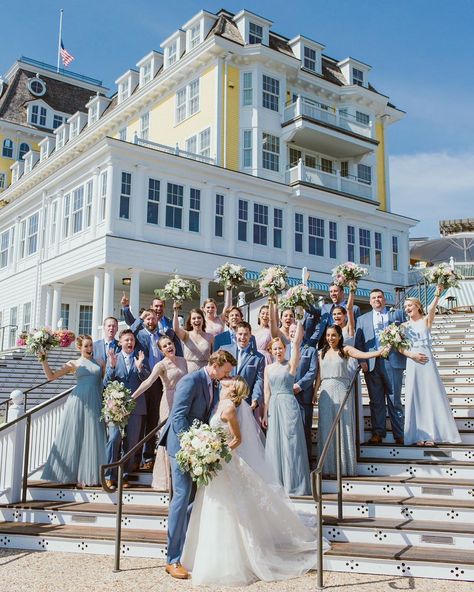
158, 368, 217, 563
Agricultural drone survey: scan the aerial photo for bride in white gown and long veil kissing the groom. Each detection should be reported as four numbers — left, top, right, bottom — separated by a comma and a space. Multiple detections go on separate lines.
181, 376, 329, 586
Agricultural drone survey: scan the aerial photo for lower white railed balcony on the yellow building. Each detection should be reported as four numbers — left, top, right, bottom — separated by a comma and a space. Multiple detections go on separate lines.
286, 161, 374, 200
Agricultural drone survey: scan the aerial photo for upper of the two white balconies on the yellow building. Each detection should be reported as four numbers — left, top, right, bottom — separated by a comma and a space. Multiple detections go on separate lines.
282, 97, 378, 158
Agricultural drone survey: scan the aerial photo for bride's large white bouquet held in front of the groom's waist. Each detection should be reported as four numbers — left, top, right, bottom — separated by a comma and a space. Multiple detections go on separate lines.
176, 419, 232, 486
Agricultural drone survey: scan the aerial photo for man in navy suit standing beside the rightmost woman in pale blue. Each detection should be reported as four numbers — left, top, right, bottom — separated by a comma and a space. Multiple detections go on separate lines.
354, 288, 406, 444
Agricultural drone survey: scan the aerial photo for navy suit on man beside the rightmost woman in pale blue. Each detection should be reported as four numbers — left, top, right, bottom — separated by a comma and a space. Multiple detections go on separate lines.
354, 310, 406, 438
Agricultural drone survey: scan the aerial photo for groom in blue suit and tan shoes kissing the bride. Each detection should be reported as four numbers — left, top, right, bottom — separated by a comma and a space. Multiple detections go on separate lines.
158, 350, 237, 580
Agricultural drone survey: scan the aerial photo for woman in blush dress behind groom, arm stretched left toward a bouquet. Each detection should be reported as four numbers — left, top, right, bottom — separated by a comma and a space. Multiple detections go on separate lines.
133, 335, 188, 491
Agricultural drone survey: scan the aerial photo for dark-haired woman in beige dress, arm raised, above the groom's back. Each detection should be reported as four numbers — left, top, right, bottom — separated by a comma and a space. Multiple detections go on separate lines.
173, 302, 214, 372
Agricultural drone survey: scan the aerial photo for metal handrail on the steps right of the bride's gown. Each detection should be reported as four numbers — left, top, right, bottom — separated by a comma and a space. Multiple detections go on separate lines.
311, 369, 359, 589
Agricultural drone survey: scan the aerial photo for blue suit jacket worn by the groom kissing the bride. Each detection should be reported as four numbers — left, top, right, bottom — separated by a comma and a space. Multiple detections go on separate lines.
158, 368, 217, 457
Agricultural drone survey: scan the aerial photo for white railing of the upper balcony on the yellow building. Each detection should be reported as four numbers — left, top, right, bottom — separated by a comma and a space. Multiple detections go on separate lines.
283, 97, 372, 138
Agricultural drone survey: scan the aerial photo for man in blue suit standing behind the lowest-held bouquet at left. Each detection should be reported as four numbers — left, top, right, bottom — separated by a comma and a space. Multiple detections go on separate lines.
104, 329, 150, 487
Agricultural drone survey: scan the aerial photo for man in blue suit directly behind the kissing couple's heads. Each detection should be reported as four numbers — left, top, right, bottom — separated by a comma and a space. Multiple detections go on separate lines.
221, 321, 265, 410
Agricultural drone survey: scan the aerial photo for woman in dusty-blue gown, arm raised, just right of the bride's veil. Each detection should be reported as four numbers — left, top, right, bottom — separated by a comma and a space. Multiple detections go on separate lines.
262, 321, 311, 495
